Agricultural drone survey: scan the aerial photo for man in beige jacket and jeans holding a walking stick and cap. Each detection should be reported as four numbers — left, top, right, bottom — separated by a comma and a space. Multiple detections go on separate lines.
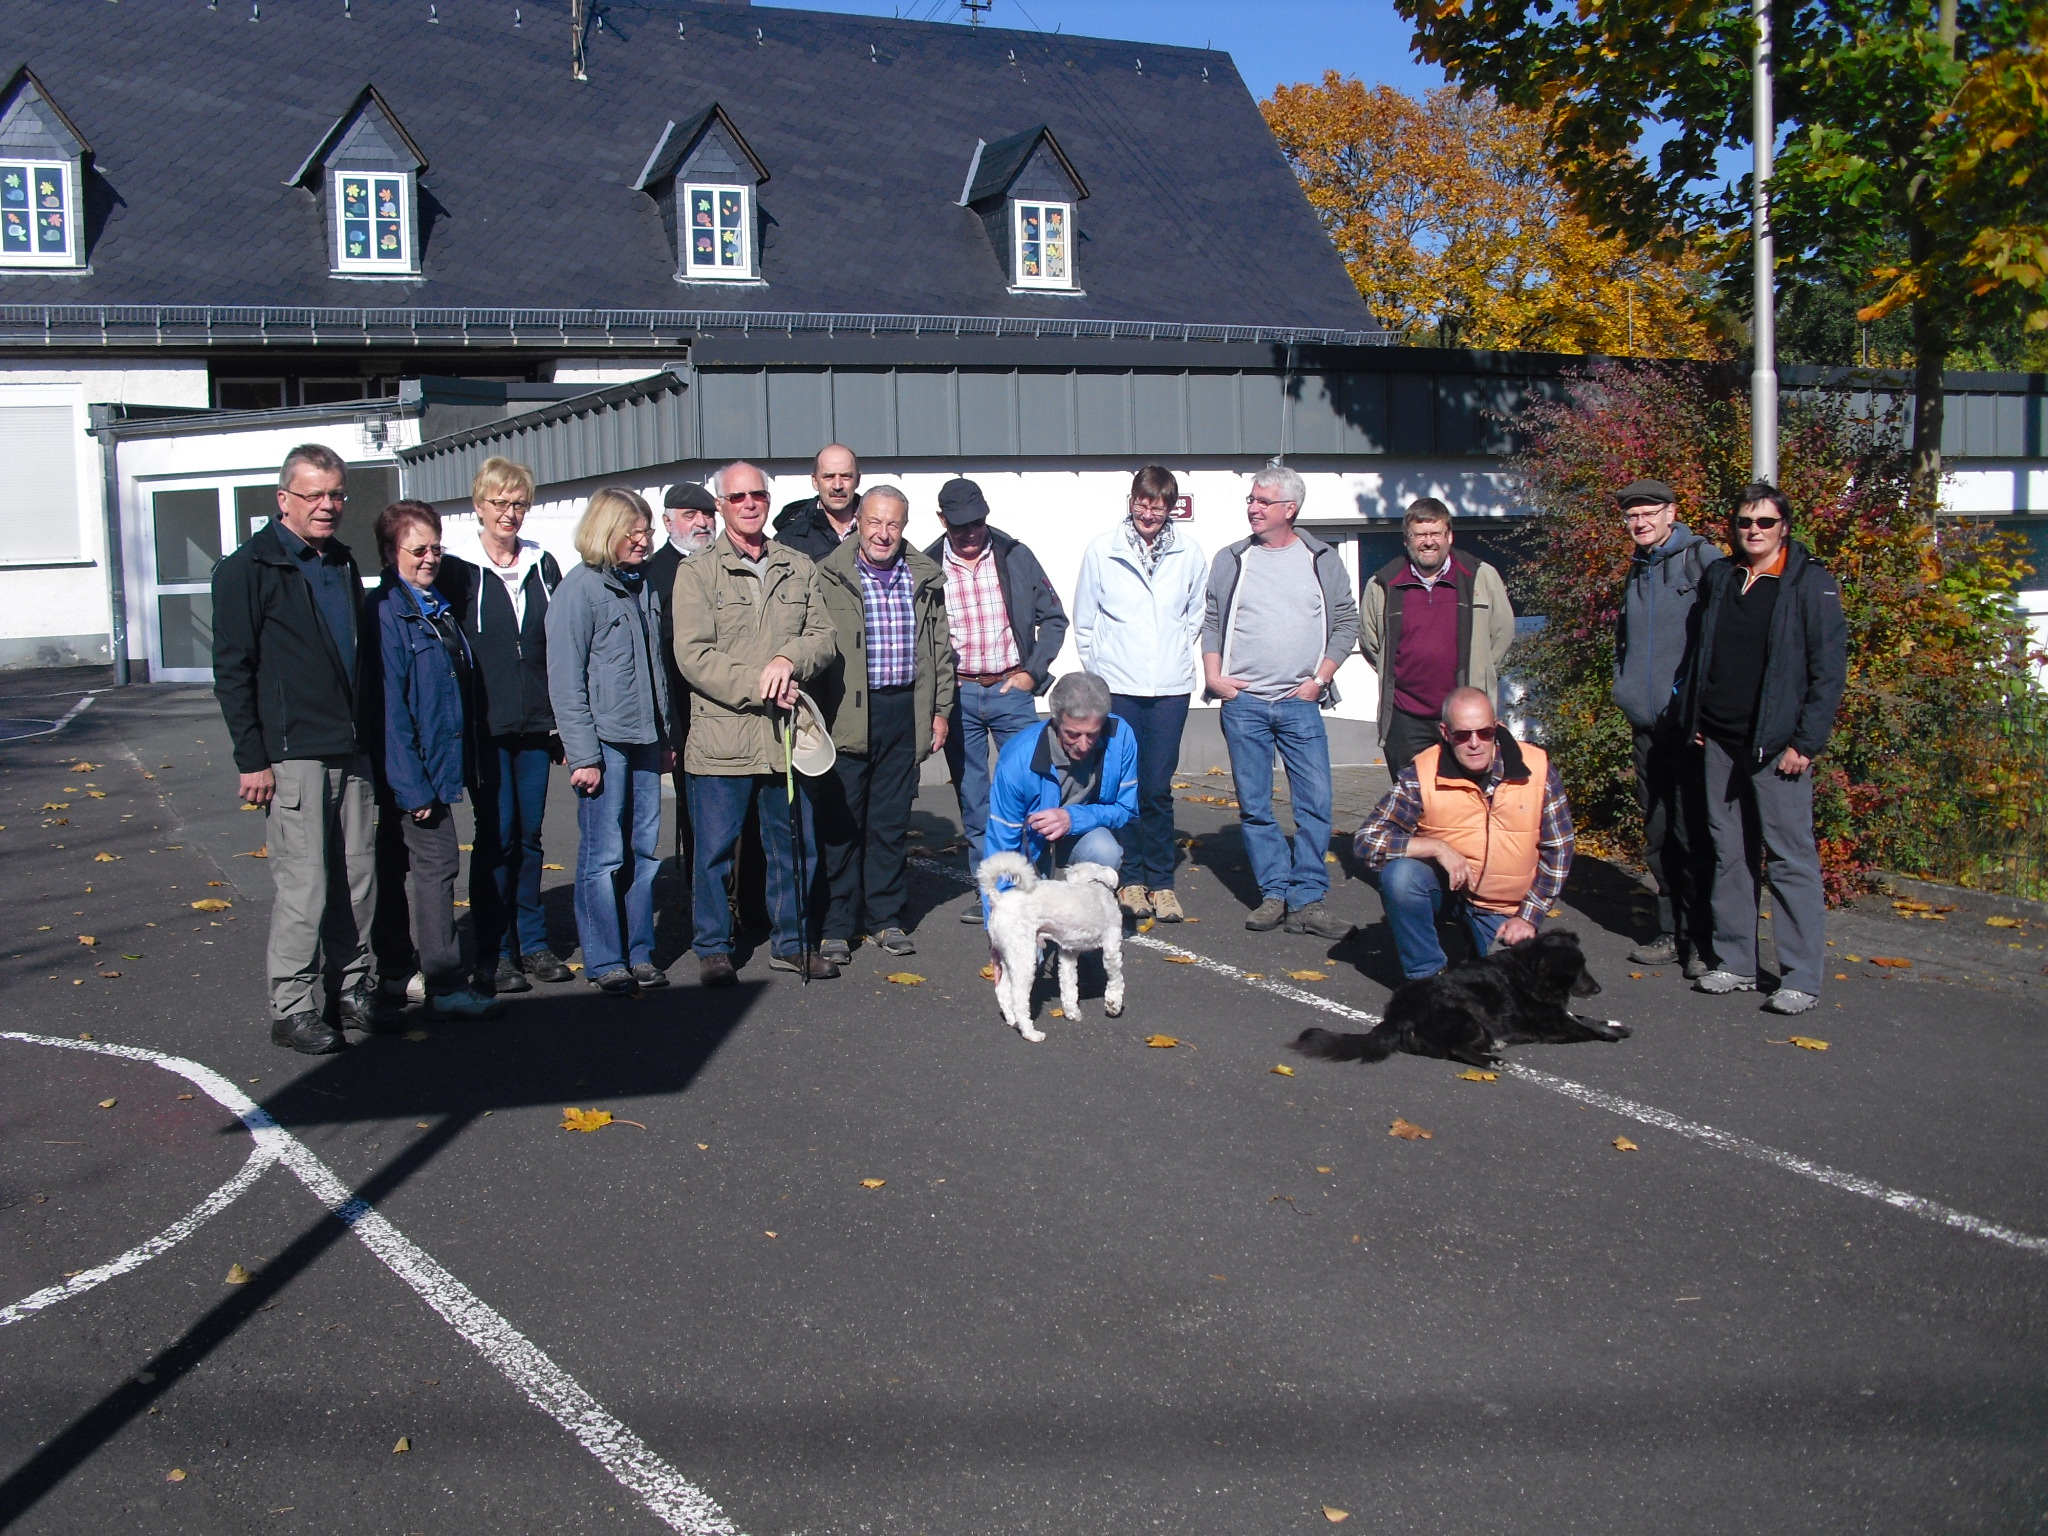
672, 463, 840, 987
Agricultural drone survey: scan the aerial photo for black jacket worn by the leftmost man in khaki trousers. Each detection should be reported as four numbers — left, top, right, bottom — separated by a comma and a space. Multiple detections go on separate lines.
213, 522, 375, 774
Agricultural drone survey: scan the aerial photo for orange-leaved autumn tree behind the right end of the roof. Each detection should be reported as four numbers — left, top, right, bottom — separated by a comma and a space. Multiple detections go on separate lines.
1260, 70, 1714, 358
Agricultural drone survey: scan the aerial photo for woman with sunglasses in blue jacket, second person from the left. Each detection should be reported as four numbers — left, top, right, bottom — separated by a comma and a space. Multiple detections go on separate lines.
362, 502, 504, 1018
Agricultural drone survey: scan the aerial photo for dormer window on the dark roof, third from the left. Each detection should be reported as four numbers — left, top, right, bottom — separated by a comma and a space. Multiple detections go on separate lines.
633, 102, 768, 283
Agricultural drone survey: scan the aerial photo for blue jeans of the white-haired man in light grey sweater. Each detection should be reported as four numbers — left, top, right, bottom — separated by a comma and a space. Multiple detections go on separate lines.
1223, 694, 1329, 907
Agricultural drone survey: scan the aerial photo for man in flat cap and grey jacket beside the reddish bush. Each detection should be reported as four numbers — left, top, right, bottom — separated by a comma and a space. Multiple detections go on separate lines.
1614, 479, 1720, 977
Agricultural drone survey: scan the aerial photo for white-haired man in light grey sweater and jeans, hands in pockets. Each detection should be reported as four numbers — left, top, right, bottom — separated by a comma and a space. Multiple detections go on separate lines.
1202, 465, 1358, 938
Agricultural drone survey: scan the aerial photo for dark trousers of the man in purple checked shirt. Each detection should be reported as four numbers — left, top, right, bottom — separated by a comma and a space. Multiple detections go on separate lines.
811, 688, 932, 940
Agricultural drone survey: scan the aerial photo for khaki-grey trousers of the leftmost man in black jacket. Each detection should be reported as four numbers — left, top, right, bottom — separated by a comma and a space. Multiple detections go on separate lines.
268, 754, 377, 1018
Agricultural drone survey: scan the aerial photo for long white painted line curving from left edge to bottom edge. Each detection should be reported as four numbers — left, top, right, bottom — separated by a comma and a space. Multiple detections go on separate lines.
0, 1030, 739, 1536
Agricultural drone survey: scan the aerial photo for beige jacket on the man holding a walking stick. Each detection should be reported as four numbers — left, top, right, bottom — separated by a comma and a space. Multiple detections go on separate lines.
672, 532, 838, 778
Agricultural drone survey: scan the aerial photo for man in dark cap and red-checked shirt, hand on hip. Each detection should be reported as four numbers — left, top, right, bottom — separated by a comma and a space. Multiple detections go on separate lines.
924, 479, 1067, 924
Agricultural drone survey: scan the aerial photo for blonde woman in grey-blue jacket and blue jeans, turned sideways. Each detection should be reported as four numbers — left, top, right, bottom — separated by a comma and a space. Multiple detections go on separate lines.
547, 485, 676, 997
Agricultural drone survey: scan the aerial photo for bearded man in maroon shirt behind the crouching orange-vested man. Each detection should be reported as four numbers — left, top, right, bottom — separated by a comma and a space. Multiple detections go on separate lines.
1358, 496, 1516, 778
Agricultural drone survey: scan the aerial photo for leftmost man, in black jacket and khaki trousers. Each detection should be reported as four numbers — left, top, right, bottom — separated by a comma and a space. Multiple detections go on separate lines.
213, 442, 381, 1055
